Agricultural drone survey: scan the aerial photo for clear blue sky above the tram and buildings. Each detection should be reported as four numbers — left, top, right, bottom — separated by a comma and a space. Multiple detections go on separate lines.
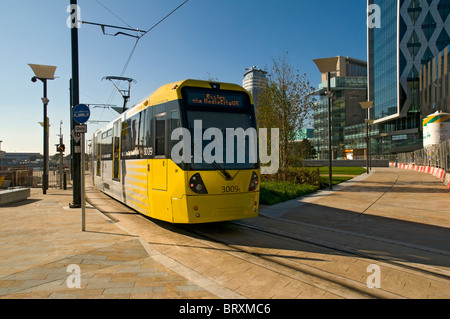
0, 0, 367, 155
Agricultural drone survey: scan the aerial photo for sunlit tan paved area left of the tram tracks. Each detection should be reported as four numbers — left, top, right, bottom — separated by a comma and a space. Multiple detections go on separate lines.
0, 189, 217, 299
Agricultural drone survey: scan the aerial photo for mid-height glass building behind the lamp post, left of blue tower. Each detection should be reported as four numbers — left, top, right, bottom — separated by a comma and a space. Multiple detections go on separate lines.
311, 56, 367, 159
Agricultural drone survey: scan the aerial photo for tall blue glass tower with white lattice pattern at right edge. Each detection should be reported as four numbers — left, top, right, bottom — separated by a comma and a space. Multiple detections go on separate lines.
368, 0, 450, 153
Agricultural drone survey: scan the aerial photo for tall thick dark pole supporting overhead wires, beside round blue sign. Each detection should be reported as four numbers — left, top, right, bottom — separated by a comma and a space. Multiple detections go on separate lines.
70, 0, 81, 208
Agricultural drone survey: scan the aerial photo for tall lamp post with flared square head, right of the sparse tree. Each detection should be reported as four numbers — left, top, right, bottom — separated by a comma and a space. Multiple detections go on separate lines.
313, 57, 338, 190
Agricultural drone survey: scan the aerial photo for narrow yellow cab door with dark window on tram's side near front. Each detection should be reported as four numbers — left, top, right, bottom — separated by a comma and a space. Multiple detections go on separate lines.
152, 109, 168, 191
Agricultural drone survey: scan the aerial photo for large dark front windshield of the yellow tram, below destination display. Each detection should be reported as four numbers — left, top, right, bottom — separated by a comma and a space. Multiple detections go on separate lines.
187, 109, 259, 170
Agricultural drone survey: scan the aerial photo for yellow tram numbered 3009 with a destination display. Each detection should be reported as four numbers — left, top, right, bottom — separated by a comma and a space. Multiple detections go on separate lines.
92, 80, 260, 223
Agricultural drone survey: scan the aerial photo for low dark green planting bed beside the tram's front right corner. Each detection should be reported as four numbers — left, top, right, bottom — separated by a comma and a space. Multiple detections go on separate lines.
260, 181, 319, 205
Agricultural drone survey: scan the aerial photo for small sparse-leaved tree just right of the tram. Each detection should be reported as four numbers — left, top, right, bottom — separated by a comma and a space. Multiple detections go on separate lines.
256, 53, 315, 170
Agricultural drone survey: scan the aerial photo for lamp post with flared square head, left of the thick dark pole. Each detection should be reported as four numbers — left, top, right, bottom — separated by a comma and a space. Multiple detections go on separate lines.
28, 64, 56, 195
